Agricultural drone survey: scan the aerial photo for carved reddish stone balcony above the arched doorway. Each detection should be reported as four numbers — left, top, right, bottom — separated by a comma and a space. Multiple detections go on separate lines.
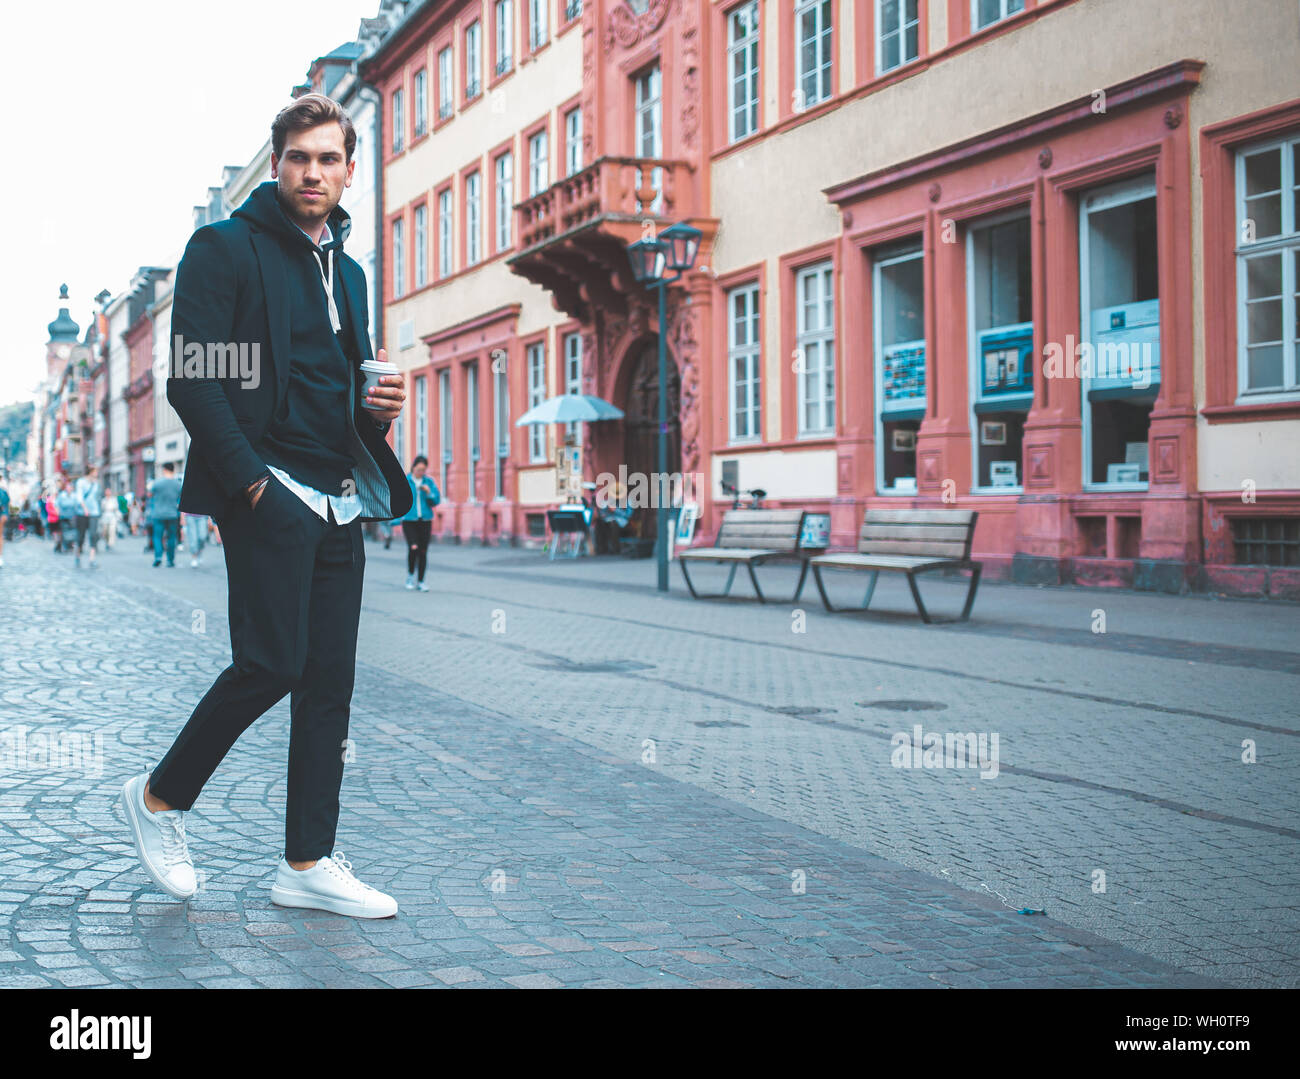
506, 156, 697, 322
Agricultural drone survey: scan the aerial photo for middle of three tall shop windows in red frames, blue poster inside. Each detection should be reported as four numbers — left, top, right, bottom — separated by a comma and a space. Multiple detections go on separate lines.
966, 211, 1035, 490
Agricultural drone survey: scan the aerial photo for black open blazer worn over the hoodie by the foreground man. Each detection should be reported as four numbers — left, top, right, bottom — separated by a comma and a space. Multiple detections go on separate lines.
166, 217, 411, 521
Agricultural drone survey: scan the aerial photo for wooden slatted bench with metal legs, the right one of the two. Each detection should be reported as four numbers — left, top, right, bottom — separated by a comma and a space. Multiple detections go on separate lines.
810, 510, 982, 623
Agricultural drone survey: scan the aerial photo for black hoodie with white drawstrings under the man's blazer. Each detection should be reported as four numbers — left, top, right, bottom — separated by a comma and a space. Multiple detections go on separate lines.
230, 179, 358, 494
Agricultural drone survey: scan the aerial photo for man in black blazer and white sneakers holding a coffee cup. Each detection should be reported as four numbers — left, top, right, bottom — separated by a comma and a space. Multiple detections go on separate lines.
122, 94, 411, 918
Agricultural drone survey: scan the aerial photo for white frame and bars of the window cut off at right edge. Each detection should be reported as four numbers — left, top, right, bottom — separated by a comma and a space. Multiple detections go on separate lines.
1234, 135, 1300, 404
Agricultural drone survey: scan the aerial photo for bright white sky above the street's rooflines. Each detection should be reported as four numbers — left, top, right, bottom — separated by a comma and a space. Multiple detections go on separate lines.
0, 0, 378, 406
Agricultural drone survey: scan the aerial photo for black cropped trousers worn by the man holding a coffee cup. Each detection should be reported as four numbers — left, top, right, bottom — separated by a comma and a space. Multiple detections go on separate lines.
150, 477, 365, 862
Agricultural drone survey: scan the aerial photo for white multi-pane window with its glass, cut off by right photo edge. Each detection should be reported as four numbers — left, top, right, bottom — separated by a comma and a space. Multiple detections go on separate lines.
1236, 139, 1300, 398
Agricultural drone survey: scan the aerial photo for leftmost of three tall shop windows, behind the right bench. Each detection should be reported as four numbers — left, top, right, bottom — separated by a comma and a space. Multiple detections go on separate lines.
872, 243, 926, 494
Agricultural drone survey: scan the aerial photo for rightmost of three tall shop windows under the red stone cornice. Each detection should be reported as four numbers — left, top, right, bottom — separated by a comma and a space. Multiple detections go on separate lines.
1076, 174, 1160, 490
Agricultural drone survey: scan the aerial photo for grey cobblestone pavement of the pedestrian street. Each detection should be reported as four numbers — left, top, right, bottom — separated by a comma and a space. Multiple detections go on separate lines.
0, 540, 1300, 987
